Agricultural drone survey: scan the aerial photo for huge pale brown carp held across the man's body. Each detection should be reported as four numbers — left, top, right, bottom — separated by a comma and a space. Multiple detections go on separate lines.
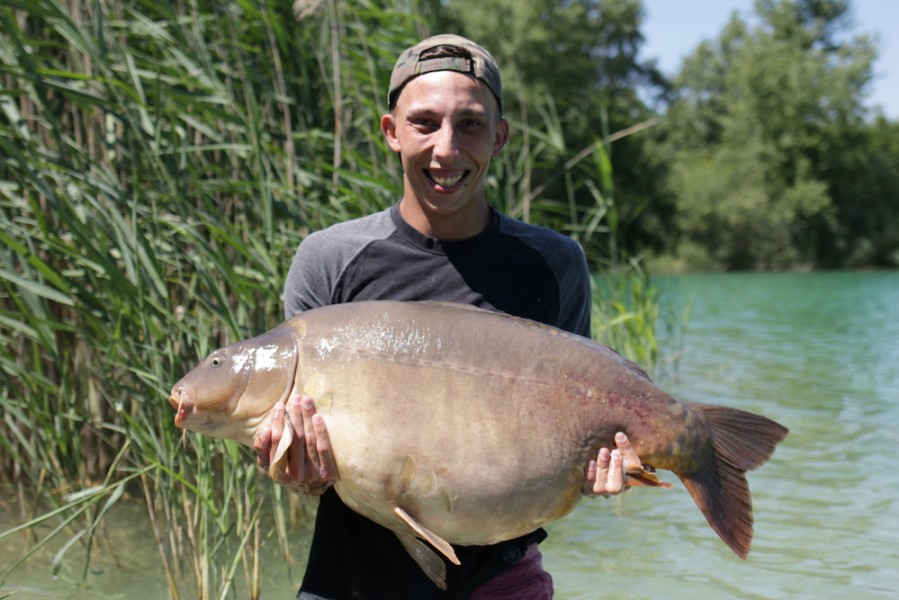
169, 301, 787, 587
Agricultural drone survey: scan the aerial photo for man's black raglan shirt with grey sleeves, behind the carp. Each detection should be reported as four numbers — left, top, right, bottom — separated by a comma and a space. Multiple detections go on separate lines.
284, 206, 591, 600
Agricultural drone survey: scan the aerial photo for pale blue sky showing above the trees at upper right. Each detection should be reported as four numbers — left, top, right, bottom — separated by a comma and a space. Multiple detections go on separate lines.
640, 0, 899, 121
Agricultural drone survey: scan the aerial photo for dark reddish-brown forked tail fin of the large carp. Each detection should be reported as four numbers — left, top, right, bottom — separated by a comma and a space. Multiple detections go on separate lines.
674, 404, 789, 558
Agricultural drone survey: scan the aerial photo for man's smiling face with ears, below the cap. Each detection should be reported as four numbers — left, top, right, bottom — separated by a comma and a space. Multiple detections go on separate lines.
381, 71, 509, 225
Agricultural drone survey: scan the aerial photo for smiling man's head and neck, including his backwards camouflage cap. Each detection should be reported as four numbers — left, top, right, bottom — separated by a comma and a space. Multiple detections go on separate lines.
381, 36, 509, 240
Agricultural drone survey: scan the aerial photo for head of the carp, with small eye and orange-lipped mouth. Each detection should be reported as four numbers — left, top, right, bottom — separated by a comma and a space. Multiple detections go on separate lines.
169, 326, 297, 445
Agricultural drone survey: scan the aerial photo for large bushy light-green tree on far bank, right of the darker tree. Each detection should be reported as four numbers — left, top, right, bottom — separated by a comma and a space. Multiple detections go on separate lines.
665, 0, 875, 268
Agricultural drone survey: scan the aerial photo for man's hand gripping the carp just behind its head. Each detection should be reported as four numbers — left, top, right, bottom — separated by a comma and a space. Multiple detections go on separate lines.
253, 395, 337, 496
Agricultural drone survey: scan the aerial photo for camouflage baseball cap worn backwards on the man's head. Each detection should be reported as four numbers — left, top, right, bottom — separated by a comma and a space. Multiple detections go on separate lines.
387, 33, 503, 113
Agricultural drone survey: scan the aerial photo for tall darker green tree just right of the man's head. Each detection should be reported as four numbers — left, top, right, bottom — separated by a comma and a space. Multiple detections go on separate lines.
444, 0, 671, 262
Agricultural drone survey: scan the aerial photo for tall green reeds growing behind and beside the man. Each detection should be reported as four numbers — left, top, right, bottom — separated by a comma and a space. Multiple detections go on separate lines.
0, 0, 652, 599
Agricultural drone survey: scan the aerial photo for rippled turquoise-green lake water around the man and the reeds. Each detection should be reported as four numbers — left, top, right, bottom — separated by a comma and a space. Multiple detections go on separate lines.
0, 272, 899, 600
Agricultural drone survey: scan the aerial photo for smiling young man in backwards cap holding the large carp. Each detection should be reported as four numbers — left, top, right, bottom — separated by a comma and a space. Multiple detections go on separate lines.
255, 35, 640, 600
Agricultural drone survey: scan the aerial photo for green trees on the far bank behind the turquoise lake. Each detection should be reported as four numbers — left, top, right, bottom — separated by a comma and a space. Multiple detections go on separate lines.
436, 0, 899, 269
